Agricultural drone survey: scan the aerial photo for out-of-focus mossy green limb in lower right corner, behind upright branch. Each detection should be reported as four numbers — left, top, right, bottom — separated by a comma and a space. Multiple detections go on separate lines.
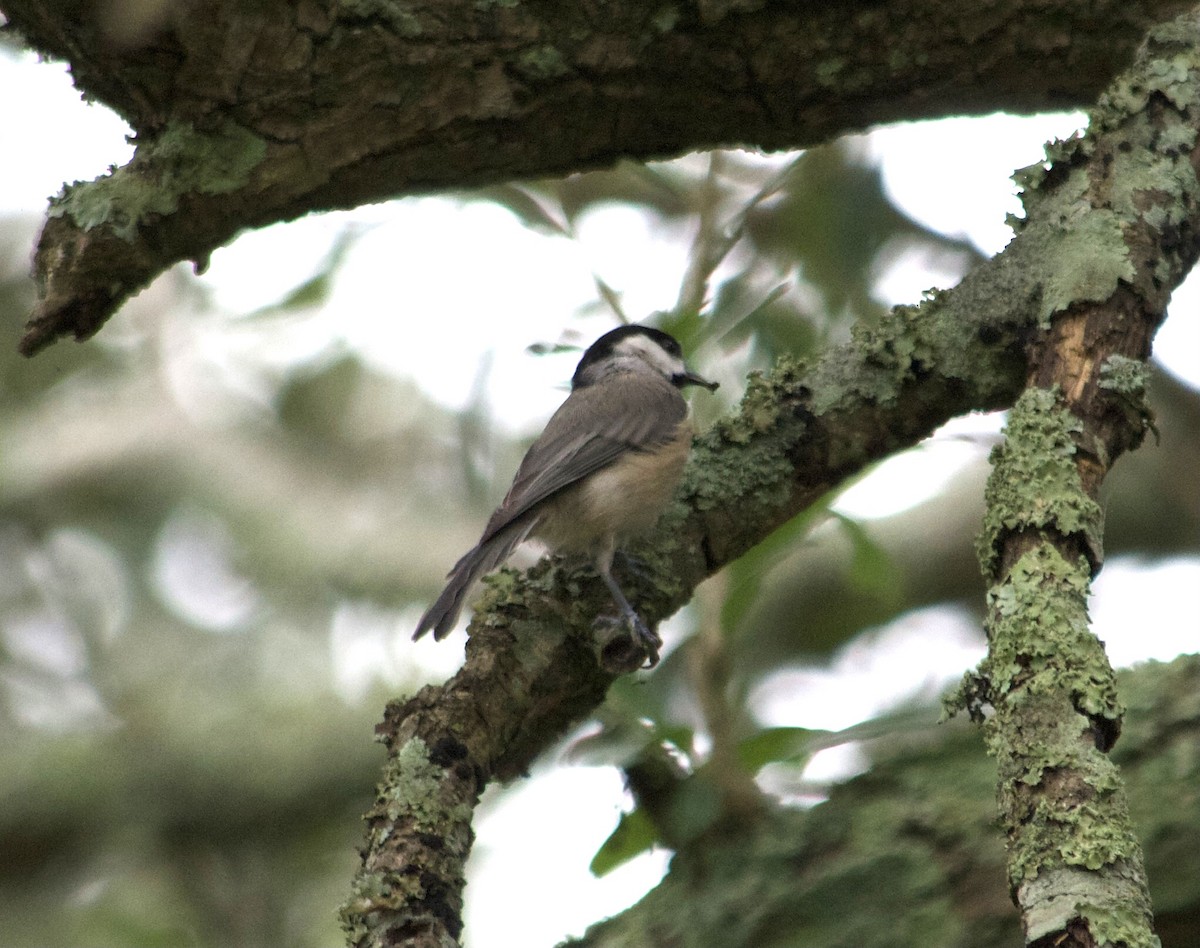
566, 655, 1200, 948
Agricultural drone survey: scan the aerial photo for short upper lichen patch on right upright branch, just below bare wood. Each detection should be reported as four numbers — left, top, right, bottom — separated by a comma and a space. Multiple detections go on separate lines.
976, 389, 1103, 575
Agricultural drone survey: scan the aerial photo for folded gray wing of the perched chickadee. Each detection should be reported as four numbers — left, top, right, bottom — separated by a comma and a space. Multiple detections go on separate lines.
480, 374, 688, 545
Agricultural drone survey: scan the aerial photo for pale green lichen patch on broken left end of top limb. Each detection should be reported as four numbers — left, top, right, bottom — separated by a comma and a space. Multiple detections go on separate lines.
49, 121, 266, 240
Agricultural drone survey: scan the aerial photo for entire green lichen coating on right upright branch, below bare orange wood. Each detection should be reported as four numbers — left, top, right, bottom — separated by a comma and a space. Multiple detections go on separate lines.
952, 376, 1152, 946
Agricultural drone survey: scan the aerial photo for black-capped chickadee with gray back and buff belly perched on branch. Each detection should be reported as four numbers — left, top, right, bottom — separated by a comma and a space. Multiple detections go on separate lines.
413, 325, 718, 667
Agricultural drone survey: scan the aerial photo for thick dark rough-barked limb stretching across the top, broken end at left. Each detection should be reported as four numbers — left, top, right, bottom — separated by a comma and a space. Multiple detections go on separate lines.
4, 0, 1184, 354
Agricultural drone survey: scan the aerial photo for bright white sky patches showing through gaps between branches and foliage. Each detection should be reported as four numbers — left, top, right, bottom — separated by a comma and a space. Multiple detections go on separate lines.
7, 52, 1200, 948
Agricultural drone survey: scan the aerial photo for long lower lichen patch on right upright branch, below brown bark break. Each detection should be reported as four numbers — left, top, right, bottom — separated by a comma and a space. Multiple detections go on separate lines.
964, 542, 1140, 912
